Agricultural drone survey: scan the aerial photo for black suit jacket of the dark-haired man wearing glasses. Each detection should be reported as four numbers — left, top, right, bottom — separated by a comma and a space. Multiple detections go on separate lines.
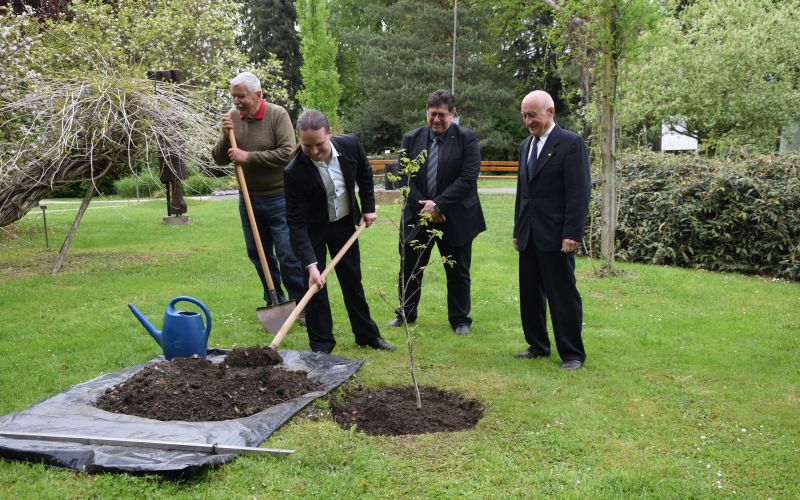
400, 124, 486, 246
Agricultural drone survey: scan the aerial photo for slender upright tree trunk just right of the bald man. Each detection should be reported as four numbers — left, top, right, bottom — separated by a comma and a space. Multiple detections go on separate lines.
600, 8, 618, 271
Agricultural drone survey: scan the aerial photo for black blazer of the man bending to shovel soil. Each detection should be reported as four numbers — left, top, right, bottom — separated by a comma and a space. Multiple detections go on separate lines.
283, 134, 375, 267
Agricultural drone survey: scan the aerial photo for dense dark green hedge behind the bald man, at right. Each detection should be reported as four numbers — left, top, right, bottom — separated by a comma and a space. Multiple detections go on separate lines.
589, 152, 800, 280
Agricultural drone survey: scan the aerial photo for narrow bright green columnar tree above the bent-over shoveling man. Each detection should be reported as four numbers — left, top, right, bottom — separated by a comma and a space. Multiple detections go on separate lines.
297, 0, 342, 130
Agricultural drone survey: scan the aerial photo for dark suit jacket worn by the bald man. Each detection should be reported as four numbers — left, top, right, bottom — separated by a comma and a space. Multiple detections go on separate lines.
514, 125, 592, 252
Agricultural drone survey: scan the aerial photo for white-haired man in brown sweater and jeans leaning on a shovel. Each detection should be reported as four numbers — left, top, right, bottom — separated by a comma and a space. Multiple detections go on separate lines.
212, 73, 306, 314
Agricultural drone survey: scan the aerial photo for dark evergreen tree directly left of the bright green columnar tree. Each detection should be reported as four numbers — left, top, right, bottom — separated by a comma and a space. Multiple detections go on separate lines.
239, 0, 302, 117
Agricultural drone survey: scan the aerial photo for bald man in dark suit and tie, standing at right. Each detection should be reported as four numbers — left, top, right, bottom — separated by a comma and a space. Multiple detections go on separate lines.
512, 90, 591, 370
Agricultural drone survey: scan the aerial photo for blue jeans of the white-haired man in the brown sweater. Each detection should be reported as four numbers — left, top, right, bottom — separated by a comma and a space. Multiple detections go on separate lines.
239, 193, 308, 304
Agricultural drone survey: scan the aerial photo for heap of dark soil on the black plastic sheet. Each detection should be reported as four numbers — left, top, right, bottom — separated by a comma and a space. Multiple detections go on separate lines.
95, 346, 321, 422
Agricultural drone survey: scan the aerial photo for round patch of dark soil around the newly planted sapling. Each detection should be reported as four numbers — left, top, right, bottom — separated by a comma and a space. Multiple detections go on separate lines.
331, 386, 483, 436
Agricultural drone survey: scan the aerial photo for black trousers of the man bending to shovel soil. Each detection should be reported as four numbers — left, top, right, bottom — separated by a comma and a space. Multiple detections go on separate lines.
306, 216, 380, 351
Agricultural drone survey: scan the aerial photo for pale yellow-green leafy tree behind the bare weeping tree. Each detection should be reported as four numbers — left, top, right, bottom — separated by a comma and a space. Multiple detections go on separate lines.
21, 0, 287, 107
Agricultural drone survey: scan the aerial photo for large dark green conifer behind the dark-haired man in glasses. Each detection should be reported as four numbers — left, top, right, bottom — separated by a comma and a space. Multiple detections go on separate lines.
334, 0, 520, 159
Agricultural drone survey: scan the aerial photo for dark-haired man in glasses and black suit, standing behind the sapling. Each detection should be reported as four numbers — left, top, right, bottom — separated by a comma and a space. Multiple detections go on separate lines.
389, 90, 486, 335
